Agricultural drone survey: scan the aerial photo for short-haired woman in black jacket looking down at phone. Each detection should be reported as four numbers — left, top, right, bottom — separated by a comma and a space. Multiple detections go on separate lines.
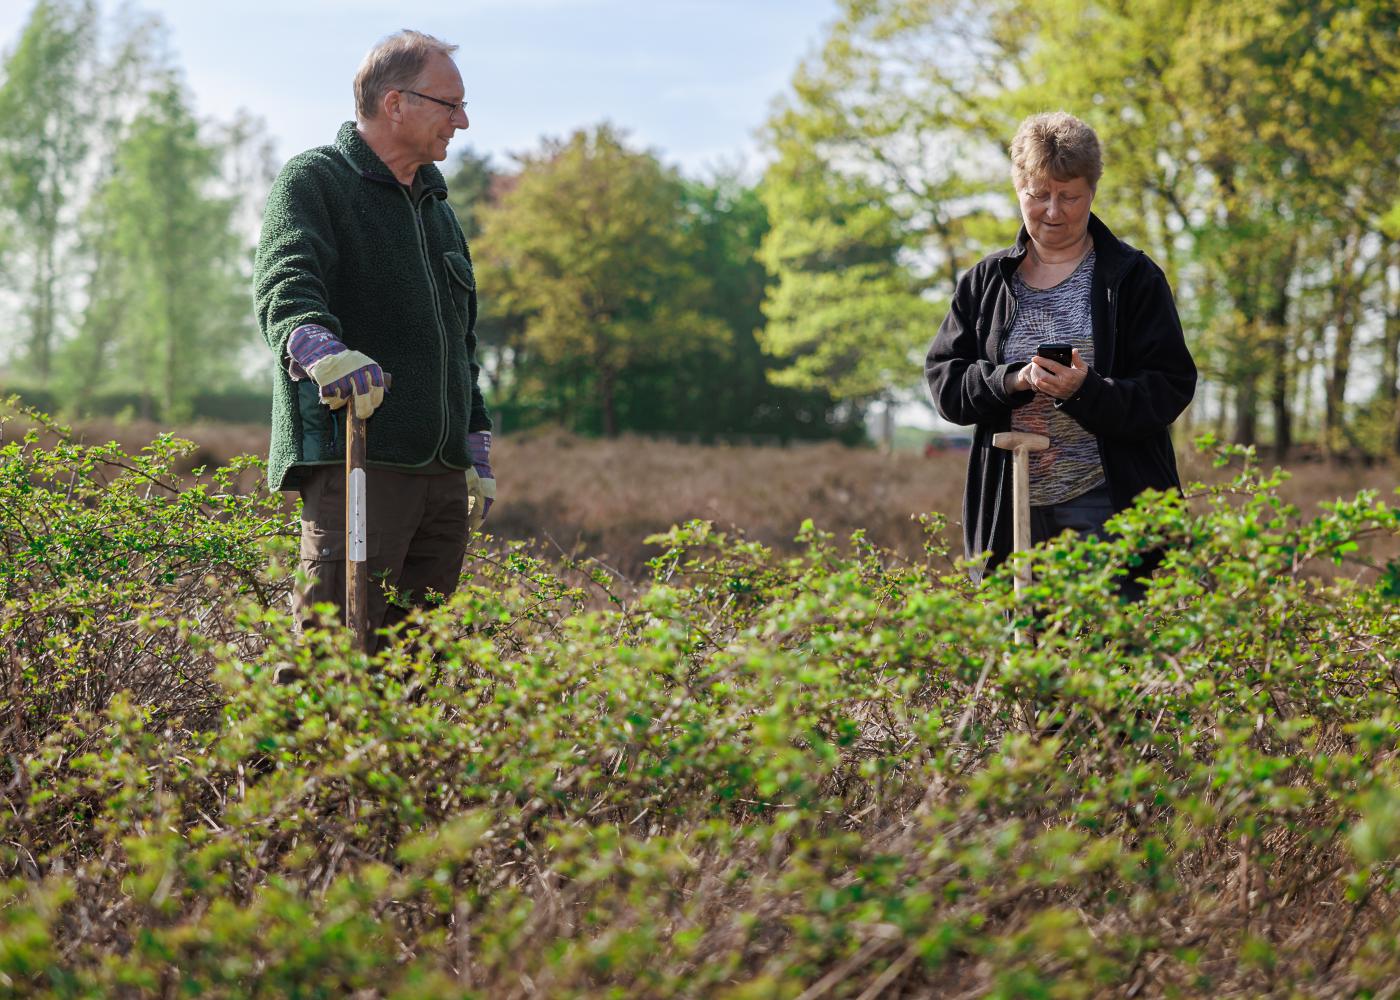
924, 112, 1196, 578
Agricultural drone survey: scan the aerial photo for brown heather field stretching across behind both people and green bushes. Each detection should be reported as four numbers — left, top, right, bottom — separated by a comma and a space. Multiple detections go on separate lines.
40, 422, 1400, 580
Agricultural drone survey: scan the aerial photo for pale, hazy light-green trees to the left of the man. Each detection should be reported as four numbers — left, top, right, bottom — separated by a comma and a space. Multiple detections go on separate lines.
0, 0, 270, 420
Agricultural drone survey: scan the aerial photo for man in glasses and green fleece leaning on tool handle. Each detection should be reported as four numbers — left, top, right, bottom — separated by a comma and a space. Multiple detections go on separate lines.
253, 31, 496, 647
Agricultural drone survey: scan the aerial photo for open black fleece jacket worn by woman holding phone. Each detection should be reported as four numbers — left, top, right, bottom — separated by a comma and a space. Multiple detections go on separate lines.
924, 214, 1196, 577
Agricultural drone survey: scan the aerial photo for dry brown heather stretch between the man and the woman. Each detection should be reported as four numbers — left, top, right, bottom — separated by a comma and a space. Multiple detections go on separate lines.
491, 425, 966, 576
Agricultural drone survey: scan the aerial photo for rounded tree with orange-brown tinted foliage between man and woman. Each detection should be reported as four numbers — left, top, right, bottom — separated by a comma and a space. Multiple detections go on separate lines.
482, 125, 725, 436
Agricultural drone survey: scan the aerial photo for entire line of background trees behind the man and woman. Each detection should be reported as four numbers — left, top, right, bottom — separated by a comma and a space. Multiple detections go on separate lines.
0, 0, 1400, 455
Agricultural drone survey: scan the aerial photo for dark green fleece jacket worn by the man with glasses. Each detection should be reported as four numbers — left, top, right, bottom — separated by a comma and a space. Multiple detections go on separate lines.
253, 122, 491, 490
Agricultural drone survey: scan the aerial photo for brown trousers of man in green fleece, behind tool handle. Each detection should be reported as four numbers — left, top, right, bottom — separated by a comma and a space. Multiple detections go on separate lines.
291, 465, 469, 647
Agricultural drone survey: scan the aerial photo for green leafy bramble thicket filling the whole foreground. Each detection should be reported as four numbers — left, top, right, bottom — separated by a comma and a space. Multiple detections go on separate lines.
0, 400, 1400, 1000
